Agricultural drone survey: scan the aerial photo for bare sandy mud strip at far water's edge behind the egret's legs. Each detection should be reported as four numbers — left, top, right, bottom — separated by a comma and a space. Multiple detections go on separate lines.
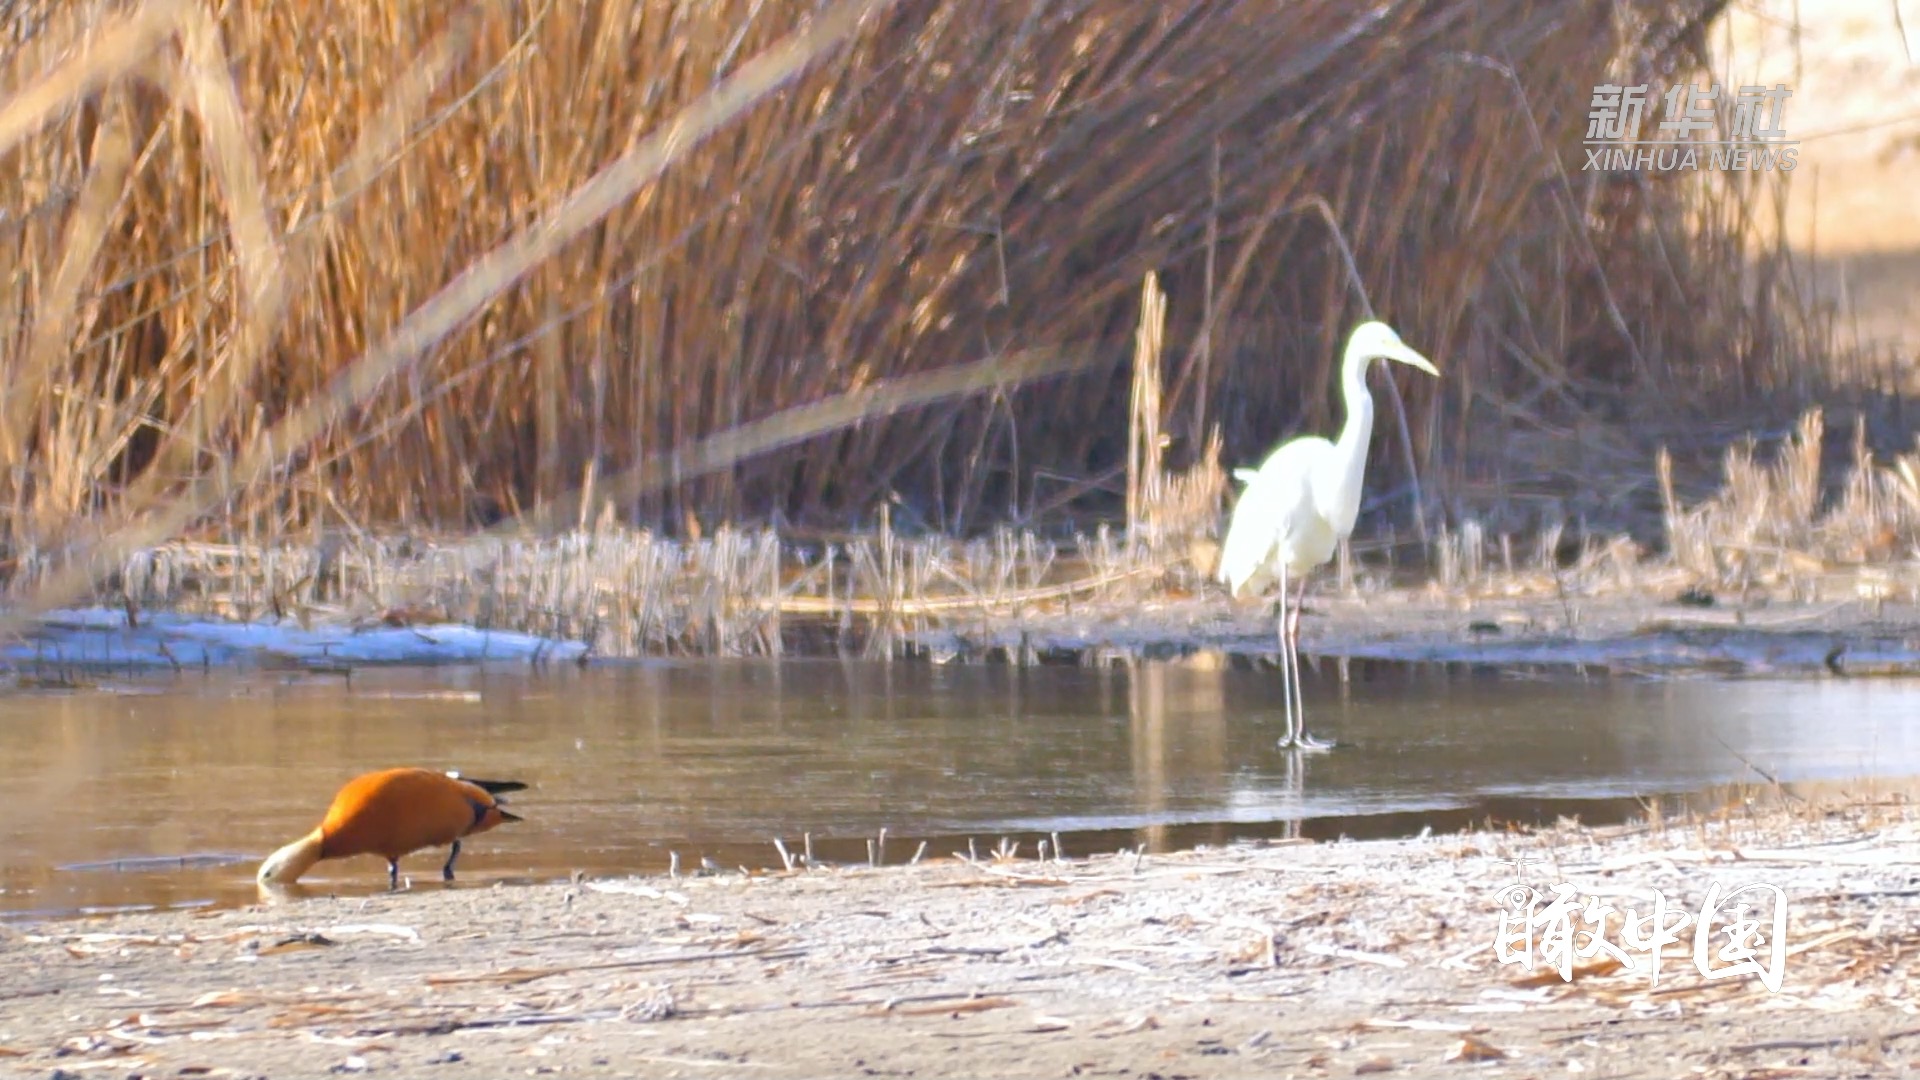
912, 573, 1920, 676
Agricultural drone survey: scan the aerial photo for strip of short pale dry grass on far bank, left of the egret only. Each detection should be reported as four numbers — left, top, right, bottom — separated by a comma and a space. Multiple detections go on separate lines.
82, 523, 1204, 661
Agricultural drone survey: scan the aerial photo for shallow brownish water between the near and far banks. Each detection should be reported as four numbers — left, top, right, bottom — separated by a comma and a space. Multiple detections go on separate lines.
0, 661, 1920, 919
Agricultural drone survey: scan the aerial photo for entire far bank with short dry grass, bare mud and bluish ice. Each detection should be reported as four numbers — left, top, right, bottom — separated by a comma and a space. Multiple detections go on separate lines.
0, 409, 1920, 675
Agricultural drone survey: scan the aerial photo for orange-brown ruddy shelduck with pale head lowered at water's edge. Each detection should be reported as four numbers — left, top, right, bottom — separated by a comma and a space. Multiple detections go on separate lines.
255, 769, 526, 888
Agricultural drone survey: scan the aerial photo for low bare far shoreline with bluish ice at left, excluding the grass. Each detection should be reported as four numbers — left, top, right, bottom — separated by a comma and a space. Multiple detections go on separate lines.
18, 567, 1920, 686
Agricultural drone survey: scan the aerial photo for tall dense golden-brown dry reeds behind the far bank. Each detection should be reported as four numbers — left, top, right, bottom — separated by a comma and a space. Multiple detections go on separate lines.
0, 0, 1824, 550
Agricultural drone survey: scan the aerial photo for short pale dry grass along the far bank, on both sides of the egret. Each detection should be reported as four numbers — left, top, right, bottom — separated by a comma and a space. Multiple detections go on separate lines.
33, 390, 1920, 663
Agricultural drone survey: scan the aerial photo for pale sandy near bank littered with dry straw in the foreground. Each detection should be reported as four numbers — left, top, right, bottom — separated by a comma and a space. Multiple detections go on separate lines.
0, 792, 1920, 1080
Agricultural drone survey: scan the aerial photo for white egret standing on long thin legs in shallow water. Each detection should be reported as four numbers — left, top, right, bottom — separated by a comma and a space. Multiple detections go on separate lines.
1217, 321, 1440, 749
